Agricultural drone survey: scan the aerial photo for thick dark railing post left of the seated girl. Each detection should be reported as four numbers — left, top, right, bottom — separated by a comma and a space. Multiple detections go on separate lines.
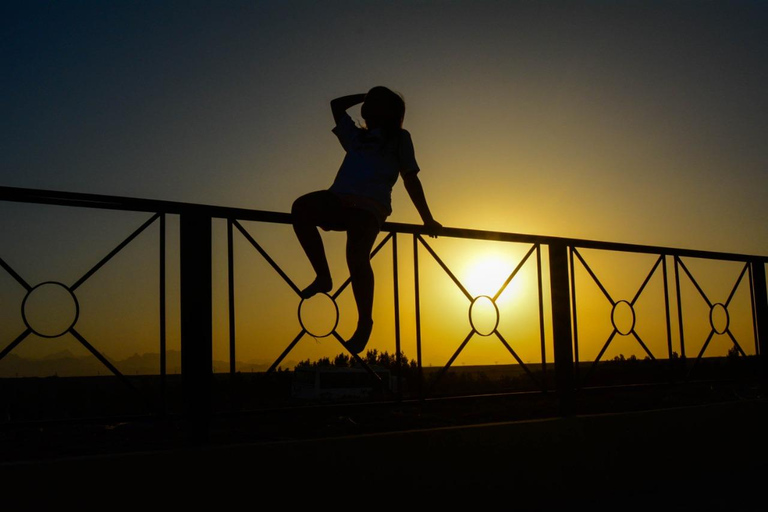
180, 213, 213, 442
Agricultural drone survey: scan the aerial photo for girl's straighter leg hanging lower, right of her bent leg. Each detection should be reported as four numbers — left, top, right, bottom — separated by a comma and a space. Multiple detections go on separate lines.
346, 212, 379, 354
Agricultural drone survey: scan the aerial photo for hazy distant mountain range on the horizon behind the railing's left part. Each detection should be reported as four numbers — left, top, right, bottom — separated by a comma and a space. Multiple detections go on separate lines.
0, 350, 296, 378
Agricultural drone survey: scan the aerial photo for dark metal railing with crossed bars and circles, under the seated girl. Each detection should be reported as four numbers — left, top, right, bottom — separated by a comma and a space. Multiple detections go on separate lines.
0, 187, 768, 418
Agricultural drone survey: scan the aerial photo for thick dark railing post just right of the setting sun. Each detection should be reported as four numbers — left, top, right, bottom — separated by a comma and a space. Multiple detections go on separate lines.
549, 243, 574, 415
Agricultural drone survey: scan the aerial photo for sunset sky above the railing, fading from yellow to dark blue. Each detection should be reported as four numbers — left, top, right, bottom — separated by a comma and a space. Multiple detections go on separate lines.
0, 0, 768, 370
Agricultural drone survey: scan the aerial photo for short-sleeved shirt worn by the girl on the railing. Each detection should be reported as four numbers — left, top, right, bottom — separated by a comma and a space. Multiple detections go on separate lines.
329, 113, 419, 225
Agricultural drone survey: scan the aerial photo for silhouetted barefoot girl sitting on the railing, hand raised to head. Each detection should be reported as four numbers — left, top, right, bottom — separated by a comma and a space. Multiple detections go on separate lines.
291, 86, 442, 354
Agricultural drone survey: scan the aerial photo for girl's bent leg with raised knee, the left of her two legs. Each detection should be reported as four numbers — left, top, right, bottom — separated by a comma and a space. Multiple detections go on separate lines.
291, 191, 338, 299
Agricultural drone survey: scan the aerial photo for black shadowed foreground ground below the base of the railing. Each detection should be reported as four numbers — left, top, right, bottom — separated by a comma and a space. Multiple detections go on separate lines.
0, 384, 768, 511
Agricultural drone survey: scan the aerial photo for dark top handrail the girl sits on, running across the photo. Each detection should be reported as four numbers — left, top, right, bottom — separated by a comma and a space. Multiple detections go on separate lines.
0, 187, 768, 263
